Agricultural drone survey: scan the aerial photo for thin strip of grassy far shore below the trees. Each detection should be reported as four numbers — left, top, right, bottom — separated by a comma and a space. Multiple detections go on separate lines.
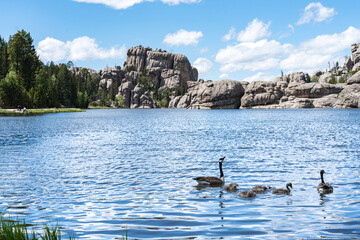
0, 108, 84, 116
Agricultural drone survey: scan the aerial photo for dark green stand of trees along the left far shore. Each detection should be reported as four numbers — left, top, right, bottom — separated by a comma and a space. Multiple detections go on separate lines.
0, 30, 100, 108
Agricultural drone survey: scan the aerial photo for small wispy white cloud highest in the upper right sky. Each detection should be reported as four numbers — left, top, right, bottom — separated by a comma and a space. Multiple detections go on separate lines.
296, 2, 336, 25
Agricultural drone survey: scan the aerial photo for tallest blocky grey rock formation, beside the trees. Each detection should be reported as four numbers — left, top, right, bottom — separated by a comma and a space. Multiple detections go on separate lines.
91, 46, 198, 108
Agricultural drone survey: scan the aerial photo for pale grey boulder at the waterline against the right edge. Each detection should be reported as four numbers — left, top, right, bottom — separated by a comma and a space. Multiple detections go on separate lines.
334, 84, 360, 108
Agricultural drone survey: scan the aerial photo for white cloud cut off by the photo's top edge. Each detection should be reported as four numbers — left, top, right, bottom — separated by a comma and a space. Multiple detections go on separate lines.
73, 0, 202, 9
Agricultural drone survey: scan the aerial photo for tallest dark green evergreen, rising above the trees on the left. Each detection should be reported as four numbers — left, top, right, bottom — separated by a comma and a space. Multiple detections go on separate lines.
8, 30, 41, 91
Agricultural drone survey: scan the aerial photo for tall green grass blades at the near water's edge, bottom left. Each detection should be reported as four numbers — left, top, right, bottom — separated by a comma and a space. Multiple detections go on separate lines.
0, 217, 75, 240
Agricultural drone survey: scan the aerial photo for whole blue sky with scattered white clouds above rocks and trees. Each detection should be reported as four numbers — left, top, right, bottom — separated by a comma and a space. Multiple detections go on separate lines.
0, 0, 360, 81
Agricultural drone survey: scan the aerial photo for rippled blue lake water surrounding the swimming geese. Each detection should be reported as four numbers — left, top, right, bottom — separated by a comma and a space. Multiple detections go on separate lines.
0, 109, 360, 239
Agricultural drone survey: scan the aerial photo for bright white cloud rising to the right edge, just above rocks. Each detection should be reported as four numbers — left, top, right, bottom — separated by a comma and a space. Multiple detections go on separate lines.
280, 27, 360, 72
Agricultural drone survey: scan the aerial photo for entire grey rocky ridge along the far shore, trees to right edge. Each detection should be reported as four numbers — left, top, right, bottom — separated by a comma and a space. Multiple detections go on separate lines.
73, 43, 360, 109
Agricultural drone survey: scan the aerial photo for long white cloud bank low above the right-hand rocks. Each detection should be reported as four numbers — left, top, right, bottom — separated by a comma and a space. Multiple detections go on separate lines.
216, 27, 360, 74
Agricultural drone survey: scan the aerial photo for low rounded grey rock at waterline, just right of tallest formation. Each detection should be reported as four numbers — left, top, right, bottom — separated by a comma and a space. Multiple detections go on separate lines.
173, 80, 244, 109
